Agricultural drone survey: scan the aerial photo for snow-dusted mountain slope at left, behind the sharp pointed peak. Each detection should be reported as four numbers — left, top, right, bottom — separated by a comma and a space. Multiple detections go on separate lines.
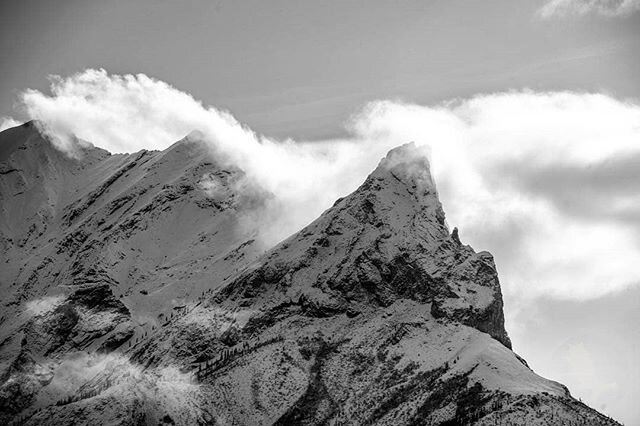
0, 122, 258, 422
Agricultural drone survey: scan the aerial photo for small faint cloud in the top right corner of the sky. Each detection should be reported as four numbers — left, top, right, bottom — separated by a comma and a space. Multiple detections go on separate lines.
538, 0, 640, 19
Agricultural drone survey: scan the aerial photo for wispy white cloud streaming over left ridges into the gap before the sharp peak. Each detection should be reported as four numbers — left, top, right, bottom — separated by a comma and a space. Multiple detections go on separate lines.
15, 69, 368, 248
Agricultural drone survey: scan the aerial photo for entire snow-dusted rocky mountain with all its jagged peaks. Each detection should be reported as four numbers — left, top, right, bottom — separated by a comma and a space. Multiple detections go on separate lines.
0, 123, 617, 425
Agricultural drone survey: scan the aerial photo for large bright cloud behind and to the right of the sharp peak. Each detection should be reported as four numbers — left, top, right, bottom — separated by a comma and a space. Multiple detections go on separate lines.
358, 92, 640, 299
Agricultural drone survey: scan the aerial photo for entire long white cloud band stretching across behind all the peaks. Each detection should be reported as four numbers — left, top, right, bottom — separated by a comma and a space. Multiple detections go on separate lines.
3, 70, 640, 300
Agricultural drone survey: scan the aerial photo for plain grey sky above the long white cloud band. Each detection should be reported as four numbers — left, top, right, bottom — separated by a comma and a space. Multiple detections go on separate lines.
0, 0, 640, 139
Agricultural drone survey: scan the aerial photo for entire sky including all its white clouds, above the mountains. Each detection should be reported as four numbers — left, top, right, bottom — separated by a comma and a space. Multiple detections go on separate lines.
0, 0, 640, 425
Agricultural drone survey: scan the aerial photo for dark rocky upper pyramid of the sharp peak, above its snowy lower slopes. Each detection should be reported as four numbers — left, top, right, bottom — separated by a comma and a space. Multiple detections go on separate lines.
224, 144, 511, 347
